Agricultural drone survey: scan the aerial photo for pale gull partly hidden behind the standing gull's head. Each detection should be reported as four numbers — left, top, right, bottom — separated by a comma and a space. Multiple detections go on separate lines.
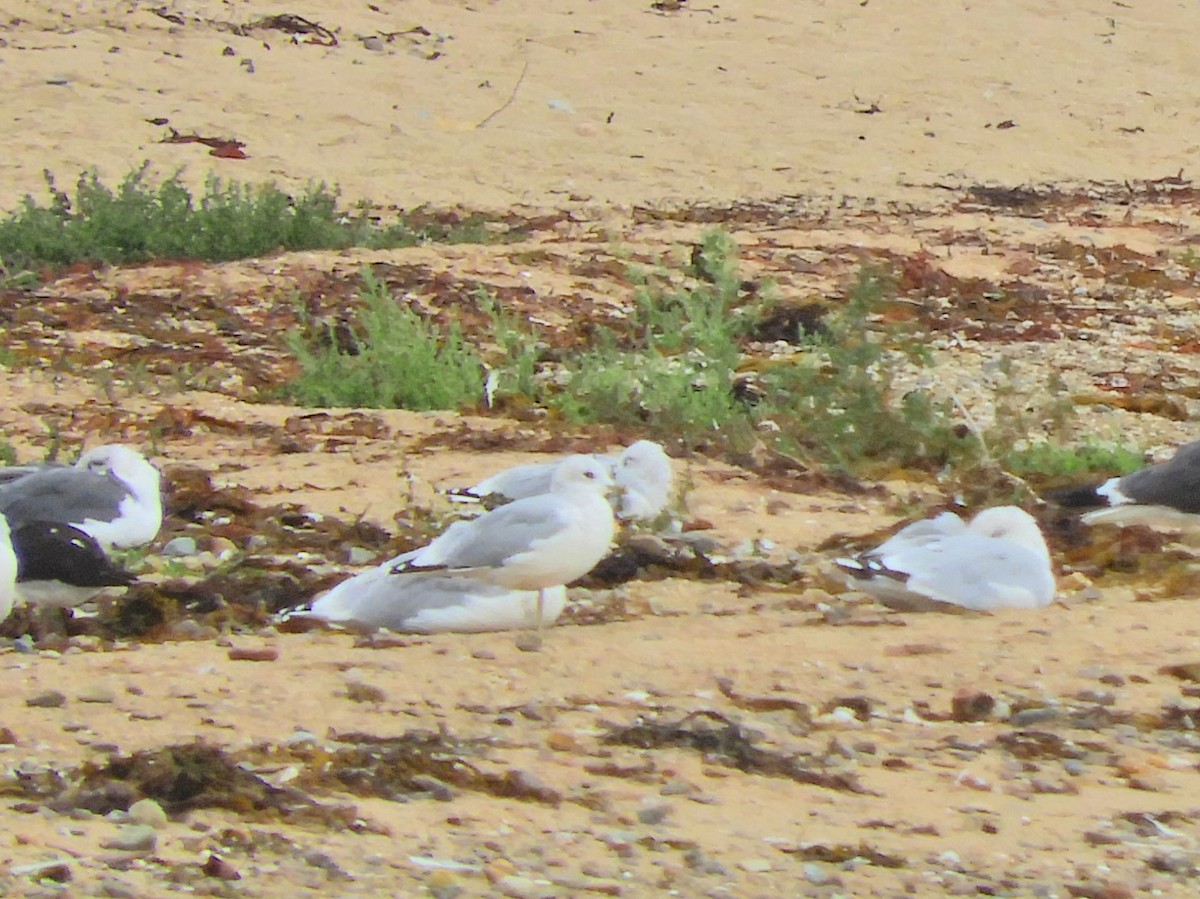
448, 440, 673, 521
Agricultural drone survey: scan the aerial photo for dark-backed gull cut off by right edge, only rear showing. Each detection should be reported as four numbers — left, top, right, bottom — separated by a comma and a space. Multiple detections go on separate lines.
1048, 440, 1200, 528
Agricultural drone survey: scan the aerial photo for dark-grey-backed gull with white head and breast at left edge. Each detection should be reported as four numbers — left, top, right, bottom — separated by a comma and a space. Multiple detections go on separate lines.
0, 444, 162, 550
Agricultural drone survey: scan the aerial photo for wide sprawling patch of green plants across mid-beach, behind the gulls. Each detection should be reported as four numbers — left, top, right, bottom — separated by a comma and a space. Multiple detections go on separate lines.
289, 232, 1141, 490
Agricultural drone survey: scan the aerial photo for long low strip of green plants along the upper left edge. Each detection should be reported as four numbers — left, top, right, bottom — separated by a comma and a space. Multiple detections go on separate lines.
0, 166, 504, 271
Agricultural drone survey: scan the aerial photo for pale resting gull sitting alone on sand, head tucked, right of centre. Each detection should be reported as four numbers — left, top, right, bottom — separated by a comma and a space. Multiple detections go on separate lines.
835, 505, 1055, 611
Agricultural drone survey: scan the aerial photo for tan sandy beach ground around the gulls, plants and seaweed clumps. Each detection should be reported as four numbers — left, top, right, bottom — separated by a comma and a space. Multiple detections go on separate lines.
0, 0, 1200, 899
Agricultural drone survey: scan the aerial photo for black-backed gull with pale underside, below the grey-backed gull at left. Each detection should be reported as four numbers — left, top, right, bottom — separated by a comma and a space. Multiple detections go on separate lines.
11, 521, 136, 609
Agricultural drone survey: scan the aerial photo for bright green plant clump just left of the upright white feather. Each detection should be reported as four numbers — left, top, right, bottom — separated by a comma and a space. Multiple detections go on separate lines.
287, 271, 484, 410
